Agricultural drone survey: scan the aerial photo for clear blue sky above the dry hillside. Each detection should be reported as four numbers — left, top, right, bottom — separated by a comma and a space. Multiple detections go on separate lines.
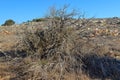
0, 0, 120, 24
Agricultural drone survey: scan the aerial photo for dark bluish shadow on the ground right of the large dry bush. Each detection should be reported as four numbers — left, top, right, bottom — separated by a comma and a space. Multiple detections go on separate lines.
83, 55, 120, 80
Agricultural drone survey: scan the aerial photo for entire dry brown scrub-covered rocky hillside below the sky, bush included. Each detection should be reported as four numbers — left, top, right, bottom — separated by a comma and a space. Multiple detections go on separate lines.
0, 5, 120, 80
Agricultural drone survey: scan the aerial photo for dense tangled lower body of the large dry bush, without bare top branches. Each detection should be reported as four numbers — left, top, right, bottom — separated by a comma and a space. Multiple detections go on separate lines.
14, 22, 85, 78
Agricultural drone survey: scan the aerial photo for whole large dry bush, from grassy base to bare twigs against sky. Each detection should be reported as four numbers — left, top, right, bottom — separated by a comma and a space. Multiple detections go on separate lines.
16, 6, 86, 80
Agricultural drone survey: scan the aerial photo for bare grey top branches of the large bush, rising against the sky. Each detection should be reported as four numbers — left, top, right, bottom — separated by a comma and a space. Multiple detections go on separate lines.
47, 5, 84, 28
